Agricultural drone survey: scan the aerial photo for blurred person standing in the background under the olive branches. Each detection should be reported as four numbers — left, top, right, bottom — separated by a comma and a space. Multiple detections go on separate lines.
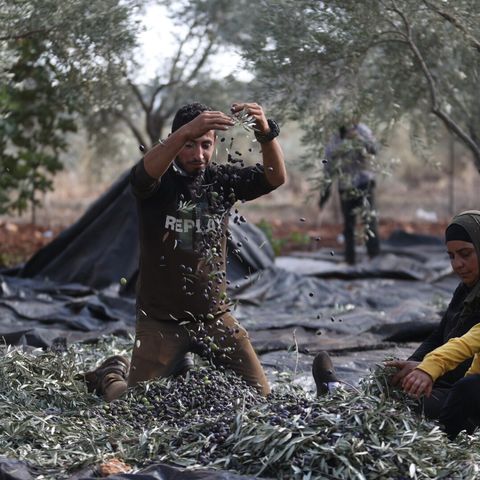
319, 120, 380, 265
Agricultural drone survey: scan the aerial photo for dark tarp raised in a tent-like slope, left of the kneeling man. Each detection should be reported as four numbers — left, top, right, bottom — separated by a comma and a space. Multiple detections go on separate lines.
13, 173, 139, 289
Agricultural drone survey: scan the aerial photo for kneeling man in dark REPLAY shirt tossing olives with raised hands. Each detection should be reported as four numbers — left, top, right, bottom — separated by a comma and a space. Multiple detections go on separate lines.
85, 103, 286, 401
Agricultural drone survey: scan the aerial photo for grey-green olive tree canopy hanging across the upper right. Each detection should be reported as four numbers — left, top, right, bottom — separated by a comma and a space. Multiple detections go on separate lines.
228, 0, 480, 169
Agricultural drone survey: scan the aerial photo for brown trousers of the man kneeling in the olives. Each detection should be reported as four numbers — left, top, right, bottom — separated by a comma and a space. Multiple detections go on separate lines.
104, 314, 270, 401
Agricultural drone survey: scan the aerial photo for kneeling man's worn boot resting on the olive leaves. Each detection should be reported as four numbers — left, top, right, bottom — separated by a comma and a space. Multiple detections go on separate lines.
81, 355, 130, 401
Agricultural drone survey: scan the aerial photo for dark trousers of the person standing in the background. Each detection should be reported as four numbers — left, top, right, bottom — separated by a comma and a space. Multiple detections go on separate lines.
340, 180, 380, 265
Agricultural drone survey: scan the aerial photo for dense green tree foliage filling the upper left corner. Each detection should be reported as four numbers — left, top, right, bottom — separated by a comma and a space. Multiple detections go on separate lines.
0, 0, 145, 216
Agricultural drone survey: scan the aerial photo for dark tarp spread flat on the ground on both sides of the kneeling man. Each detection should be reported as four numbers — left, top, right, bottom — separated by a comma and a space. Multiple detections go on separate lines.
0, 255, 455, 480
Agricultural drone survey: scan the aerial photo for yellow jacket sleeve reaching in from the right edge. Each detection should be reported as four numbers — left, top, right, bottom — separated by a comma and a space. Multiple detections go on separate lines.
417, 324, 480, 381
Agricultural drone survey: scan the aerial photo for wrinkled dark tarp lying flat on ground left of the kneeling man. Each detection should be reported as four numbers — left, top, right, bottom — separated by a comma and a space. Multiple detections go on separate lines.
0, 275, 135, 348
